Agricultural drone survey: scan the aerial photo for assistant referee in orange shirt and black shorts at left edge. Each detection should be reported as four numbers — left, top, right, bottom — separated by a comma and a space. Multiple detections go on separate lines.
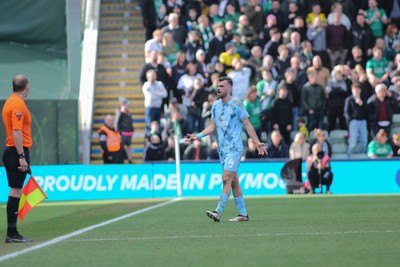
2, 75, 32, 243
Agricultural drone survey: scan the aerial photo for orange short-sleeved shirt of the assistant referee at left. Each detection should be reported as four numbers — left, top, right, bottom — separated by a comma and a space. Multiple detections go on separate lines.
2, 94, 32, 148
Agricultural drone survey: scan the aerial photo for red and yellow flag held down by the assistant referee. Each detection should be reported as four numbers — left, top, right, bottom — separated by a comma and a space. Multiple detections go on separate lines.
18, 176, 47, 222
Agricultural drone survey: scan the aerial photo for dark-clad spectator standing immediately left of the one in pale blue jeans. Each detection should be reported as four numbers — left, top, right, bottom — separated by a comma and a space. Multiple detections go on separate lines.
326, 66, 348, 132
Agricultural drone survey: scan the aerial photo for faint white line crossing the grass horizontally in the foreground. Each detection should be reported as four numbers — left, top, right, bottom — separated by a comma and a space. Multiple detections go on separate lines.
67, 230, 400, 242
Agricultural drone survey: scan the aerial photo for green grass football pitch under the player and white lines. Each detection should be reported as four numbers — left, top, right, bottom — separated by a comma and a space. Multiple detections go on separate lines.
0, 195, 400, 267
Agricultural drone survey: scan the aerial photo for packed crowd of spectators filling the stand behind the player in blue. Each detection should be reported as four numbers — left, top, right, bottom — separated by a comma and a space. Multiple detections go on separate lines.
139, 0, 400, 161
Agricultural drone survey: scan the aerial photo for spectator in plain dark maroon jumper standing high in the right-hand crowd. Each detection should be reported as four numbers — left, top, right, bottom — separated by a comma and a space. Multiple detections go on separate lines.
326, 12, 349, 69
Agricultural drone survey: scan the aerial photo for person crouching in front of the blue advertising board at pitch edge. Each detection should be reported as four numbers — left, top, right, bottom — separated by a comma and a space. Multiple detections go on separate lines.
306, 144, 333, 194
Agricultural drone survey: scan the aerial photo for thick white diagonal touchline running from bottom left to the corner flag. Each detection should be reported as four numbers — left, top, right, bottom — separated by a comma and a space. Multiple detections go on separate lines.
0, 198, 182, 262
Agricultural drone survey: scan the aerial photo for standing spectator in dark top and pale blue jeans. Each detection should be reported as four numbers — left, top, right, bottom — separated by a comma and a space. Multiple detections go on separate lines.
344, 83, 368, 158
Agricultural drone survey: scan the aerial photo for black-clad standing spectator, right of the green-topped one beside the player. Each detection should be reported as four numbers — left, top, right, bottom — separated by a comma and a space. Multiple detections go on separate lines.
269, 83, 293, 144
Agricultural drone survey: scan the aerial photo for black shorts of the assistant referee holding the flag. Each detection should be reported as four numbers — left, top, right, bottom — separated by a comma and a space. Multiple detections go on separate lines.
3, 147, 29, 188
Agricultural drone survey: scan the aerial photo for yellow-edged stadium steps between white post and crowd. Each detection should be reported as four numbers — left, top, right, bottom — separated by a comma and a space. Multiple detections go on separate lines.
90, 0, 145, 164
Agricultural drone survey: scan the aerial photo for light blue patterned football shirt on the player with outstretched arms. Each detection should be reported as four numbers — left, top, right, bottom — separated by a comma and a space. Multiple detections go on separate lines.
211, 98, 249, 158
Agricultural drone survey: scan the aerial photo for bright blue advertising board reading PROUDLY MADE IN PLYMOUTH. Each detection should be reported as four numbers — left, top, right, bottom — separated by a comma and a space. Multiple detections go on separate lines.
0, 160, 400, 202
